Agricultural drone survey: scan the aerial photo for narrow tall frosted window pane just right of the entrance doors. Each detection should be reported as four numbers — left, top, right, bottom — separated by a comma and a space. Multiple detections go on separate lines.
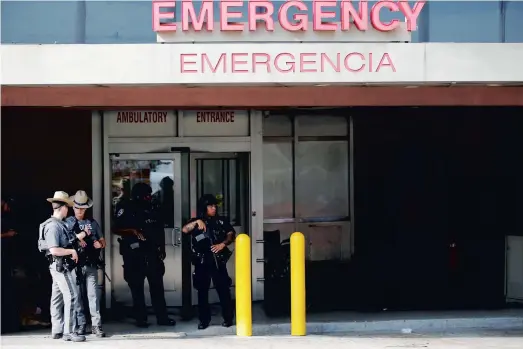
263, 142, 293, 218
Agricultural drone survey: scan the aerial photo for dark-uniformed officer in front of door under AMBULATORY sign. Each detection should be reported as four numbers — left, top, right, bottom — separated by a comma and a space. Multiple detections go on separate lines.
113, 183, 176, 327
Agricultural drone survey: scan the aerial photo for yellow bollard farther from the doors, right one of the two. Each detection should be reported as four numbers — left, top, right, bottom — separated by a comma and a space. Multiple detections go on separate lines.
291, 232, 307, 336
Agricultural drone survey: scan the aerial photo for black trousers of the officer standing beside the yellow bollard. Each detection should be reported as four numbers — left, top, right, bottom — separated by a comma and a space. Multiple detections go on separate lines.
193, 256, 234, 324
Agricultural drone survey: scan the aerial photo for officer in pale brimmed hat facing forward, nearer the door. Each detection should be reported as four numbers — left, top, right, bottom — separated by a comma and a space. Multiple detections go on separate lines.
66, 190, 105, 338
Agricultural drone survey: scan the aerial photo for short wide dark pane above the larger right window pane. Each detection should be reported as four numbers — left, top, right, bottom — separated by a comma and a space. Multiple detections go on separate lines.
297, 115, 347, 136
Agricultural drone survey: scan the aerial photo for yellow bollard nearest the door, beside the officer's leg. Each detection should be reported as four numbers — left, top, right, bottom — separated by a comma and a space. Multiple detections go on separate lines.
235, 234, 252, 337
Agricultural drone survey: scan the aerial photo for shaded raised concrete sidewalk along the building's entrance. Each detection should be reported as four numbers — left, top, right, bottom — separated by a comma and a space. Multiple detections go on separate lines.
5, 306, 523, 340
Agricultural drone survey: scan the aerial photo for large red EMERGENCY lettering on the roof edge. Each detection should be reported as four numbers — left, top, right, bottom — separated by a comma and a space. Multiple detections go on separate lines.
152, 0, 425, 32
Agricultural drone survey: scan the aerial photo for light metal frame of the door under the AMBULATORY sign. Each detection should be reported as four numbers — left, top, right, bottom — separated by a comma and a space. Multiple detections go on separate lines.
105, 152, 186, 307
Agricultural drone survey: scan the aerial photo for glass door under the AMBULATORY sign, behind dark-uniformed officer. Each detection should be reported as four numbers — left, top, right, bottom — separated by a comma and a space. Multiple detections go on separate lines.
110, 154, 183, 307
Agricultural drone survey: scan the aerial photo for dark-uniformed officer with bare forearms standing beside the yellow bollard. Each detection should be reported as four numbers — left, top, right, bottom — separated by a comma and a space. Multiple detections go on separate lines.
182, 194, 236, 330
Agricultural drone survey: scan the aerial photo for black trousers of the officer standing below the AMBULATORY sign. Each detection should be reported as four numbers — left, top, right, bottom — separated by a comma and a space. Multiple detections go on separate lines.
123, 254, 167, 322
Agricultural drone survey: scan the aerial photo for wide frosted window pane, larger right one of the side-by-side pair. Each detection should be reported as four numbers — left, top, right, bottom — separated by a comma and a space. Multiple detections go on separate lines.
296, 141, 349, 218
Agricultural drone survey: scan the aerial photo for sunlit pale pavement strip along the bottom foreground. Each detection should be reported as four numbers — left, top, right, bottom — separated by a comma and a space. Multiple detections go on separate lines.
2, 330, 523, 349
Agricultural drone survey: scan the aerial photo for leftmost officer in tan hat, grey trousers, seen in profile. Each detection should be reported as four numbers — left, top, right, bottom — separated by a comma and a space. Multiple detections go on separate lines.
38, 191, 85, 342
